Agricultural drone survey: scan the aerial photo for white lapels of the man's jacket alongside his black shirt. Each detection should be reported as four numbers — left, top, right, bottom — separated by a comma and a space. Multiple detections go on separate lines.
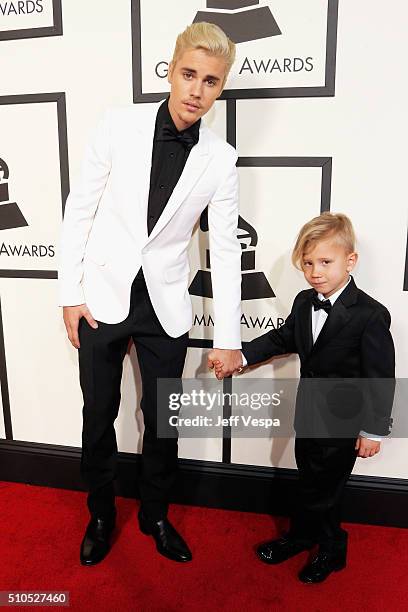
146, 123, 211, 244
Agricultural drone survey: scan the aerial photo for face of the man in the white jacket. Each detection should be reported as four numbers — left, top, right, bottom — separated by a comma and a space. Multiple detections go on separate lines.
168, 49, 226, 130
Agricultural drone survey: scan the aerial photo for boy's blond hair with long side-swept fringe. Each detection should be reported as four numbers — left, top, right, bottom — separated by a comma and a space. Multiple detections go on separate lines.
292, 212, 356, 270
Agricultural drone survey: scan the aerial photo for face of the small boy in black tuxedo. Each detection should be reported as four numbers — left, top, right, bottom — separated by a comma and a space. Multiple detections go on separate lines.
302, 238, 357, 298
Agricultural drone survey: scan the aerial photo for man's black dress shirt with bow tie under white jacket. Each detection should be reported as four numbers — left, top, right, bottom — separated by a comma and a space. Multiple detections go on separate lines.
147, 99, 201, 235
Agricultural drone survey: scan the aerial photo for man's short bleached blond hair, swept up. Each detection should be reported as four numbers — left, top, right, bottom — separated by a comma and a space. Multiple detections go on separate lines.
171, 21, 235, 86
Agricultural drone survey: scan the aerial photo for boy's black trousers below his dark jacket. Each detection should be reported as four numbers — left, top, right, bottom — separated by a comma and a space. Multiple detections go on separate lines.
289, 438, 356, 554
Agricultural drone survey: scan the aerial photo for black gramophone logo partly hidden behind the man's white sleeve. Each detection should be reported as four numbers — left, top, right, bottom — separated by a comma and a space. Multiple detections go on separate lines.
189, 209, 275, 300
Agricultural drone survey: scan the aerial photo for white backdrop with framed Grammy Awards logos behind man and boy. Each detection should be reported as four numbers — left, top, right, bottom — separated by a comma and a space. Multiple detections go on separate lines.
0, 0, 408, 478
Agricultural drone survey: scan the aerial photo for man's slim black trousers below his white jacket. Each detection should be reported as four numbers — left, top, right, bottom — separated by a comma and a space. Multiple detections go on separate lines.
78, 270, 188, 520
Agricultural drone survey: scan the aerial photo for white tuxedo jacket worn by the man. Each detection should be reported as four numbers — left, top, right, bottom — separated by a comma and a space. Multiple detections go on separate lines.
59, 102, 241, 349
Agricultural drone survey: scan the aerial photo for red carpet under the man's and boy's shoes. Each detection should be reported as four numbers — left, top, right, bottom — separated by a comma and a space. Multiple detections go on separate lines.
0, 482, 408, 612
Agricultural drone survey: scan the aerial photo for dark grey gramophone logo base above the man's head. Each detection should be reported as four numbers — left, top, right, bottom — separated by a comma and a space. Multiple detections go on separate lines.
194, 0, 282, 43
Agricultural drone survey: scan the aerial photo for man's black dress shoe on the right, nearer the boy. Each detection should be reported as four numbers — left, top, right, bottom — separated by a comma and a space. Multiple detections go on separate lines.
138, 512, 192, 561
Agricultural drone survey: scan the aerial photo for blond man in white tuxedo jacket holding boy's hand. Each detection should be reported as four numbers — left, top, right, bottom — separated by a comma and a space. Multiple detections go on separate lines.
59, 23, 241, 565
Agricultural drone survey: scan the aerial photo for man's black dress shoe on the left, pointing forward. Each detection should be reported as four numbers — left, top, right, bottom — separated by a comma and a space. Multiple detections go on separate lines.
80, 512, 116, 565
